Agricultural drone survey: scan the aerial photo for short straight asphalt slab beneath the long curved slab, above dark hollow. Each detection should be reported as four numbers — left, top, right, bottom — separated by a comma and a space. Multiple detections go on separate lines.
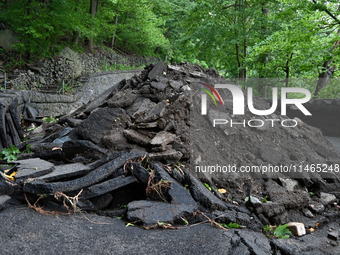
81, 176, 136, 199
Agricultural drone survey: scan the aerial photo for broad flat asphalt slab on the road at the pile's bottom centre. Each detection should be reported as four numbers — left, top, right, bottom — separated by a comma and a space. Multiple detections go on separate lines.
127, 200, 195, 225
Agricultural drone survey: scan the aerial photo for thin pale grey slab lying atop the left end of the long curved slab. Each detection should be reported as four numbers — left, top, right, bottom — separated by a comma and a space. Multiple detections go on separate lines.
38, 163, 91, 182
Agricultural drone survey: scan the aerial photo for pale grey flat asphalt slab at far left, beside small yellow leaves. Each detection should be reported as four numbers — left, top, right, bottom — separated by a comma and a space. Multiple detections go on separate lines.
15, 158, 54, 183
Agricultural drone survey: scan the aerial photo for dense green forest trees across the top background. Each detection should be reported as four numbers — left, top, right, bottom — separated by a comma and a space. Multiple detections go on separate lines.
0, 0, 340, 97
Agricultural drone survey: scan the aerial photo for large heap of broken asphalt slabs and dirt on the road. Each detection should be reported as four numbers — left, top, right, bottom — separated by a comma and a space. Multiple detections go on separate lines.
0, 62, 340, 254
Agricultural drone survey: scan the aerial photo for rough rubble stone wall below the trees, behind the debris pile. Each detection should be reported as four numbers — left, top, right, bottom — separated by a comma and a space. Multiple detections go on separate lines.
0, 48, 158, 92
